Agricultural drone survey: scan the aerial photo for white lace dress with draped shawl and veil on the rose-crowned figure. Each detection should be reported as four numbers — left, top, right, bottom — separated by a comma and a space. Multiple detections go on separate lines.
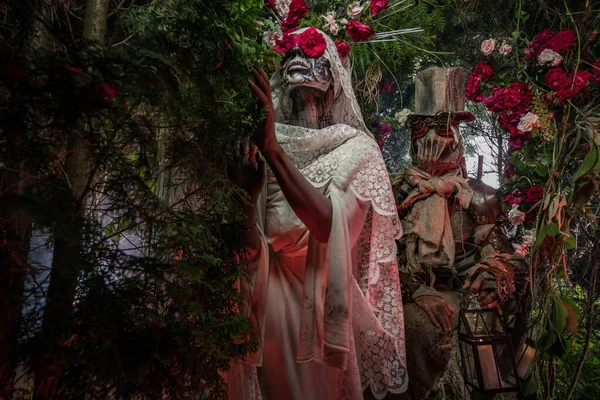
228, 28, 408, 400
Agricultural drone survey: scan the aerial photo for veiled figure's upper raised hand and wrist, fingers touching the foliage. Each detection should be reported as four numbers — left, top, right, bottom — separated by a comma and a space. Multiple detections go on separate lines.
250, 66, 279, 154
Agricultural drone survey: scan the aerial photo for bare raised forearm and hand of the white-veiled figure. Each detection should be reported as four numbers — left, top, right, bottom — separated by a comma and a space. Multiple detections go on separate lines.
250, 67, 332, 243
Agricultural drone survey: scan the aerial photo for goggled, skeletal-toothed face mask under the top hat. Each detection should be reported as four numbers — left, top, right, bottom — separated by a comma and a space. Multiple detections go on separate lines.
410, 113, 464, 175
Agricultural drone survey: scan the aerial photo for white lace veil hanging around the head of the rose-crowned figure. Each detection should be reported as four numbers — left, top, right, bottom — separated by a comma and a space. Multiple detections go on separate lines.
271, 28, 373, 137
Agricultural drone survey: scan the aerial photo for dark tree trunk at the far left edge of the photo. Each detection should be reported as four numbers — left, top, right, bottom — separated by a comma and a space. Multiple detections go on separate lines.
0, 2, 51, 400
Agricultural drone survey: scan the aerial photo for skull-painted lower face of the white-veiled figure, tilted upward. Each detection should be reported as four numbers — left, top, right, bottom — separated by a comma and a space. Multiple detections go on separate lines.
282, 46, 333, 94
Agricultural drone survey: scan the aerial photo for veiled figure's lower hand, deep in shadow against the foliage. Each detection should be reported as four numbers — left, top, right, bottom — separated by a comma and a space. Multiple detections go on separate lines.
227, 140, 266, 205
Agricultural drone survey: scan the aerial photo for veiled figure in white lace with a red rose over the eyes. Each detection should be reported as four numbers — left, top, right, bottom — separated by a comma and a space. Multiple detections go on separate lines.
227, 28, 408, 400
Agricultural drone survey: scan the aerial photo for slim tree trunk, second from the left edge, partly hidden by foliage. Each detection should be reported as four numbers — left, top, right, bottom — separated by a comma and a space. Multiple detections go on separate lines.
34, 0, 109, 400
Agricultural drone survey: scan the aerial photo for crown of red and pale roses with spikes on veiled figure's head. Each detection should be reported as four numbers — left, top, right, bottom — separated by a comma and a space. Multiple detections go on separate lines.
264, 0, 422, 60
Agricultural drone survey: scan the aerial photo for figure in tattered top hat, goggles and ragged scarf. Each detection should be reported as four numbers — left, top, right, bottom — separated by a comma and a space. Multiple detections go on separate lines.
394, 68, 521, 400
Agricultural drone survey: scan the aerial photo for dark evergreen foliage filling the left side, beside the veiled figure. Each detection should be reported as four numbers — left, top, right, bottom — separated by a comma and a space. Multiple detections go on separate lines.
0, 0, 276, 399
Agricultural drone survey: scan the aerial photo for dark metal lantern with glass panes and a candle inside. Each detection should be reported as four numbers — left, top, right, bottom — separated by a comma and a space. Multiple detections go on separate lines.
458, 307, 519, 393
